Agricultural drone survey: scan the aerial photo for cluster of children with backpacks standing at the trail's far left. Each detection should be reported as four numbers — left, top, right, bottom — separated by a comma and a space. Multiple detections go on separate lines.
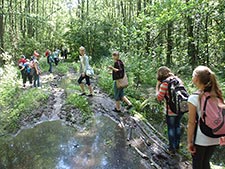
18, 51, 41, 88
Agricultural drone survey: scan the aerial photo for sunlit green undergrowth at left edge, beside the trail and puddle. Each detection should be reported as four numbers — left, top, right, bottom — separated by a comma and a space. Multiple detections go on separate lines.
0, 65, 48, 133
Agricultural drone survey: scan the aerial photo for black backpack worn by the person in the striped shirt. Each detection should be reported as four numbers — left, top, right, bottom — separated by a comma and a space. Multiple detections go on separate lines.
163, 78, 189, 115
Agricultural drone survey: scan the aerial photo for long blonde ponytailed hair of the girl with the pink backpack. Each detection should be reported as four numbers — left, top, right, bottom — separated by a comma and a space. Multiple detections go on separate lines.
193, 66, 223, 101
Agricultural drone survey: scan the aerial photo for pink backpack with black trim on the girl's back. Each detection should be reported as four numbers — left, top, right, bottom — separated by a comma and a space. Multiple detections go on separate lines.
199, 92, 225, 138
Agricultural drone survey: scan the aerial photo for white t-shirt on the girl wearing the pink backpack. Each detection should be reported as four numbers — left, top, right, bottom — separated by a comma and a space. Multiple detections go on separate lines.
188, 95, 219, 146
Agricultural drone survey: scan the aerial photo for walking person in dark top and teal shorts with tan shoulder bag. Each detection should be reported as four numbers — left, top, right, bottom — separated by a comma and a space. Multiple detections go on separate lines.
108, 51, 133, 113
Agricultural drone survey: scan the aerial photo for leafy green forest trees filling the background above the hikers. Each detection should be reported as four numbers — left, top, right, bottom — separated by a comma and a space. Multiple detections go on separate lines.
0, 0, 225, 71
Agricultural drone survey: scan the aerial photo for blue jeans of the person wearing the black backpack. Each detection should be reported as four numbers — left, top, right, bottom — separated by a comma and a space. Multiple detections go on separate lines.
166, 115, 182, 150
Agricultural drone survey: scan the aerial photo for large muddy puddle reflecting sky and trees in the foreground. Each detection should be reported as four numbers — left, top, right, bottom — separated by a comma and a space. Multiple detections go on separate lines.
0, 115, 149, 169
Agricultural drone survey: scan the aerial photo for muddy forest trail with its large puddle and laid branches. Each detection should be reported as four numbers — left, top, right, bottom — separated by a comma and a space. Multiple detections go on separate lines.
0, 70, 191, 169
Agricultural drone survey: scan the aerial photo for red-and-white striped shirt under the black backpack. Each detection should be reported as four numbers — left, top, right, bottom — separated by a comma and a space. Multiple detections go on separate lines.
157, 77, 177, 116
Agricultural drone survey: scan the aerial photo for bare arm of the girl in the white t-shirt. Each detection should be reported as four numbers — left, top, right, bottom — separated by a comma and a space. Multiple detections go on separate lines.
187, 103, 197, 154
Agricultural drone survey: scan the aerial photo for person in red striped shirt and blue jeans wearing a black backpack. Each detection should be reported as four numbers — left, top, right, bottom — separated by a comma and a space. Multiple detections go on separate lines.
156, 66, 185, 155
